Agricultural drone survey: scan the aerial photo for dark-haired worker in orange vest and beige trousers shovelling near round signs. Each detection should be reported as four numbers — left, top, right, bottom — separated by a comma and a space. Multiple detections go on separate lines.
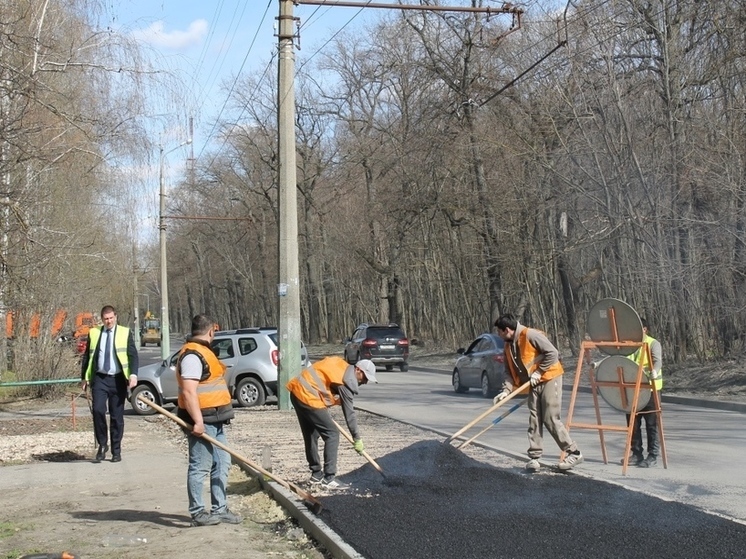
494, 314, 583, 472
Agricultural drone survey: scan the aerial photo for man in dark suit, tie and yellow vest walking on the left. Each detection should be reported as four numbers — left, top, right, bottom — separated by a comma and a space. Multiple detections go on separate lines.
81, 305, 139, 462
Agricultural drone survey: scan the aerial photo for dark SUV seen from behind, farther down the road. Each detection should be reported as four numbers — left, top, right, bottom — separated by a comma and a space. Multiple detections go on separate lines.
344, 324, 409, 372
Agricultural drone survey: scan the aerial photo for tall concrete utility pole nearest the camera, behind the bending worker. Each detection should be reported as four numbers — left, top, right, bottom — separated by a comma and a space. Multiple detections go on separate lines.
277, 0, 301, 410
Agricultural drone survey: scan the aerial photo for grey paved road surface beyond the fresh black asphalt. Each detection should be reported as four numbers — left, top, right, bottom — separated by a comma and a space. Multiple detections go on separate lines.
355, 369, 746, 523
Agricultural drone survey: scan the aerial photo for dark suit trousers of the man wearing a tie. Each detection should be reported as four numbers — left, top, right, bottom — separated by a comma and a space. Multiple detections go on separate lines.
91, 373, 127, 454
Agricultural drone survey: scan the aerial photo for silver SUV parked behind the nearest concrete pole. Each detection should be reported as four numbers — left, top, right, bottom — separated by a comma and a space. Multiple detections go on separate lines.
130, 328, 310, 415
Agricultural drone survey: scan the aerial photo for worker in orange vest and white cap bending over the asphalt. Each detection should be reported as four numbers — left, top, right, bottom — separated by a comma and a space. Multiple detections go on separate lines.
286, 356, 378, 489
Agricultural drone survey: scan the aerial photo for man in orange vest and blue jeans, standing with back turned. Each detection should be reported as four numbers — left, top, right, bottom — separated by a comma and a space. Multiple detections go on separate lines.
176, 314, 238, 526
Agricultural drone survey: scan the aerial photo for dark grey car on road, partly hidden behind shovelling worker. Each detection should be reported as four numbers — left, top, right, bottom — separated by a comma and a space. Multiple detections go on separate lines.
451, 333, 505, 398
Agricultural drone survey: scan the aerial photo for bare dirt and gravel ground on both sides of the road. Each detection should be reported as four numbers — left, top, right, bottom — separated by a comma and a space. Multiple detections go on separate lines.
0, 346, 746, 559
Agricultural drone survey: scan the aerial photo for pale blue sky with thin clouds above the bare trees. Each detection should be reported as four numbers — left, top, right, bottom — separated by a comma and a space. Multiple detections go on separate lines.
99, 0, 378, 158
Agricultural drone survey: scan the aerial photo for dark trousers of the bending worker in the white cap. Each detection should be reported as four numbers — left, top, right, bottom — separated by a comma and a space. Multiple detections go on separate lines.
290, 394, 339, 476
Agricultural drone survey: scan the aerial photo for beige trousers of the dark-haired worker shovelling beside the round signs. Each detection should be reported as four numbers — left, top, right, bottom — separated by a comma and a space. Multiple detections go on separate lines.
526, 375, 578, 459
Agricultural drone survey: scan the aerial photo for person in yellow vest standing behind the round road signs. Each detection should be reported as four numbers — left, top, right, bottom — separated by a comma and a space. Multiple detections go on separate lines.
627, 318, 663, 468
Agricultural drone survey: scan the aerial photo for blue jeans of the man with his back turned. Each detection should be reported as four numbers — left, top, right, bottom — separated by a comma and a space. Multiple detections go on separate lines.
187, 423, 231, 517
